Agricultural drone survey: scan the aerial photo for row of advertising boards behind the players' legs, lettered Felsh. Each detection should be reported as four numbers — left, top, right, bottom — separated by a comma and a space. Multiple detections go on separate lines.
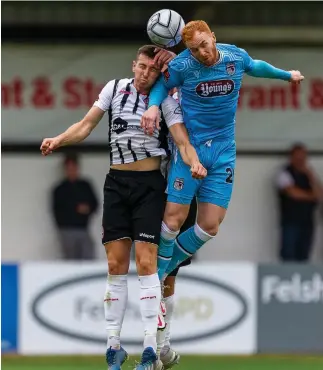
1, 262, 323, 355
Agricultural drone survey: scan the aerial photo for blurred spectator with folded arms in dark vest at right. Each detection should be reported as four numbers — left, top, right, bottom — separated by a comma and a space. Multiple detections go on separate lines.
276, 144, 323, 262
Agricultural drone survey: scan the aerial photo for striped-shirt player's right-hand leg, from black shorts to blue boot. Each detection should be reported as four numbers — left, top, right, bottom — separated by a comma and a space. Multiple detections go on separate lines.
131, 171, 165, 369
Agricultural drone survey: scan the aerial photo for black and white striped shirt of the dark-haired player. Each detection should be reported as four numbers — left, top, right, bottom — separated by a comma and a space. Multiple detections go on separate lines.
94, 78, 183, 165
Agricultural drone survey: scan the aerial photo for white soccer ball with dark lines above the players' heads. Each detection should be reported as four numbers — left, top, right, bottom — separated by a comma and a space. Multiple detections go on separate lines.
147, 9, 185, 48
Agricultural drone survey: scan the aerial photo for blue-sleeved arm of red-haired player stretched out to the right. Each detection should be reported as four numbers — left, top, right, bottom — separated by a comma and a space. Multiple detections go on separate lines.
240, 49, 304, 83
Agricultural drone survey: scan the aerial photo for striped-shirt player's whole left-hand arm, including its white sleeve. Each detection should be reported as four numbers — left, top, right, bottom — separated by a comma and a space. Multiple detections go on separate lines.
40, 81, 114, 156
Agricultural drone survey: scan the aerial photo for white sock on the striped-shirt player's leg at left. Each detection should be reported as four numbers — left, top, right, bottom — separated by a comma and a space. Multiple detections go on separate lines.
104, 275, 128, 349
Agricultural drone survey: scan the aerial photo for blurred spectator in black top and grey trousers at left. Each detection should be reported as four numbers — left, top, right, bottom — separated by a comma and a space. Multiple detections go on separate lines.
52, 155, 98, 259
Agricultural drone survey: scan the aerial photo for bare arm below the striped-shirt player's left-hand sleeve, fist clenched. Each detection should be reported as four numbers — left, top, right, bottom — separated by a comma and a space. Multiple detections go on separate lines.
40, 107, 105, 156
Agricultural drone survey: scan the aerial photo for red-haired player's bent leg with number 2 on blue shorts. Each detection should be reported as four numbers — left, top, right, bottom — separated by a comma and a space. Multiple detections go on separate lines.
166, 141, 236, 273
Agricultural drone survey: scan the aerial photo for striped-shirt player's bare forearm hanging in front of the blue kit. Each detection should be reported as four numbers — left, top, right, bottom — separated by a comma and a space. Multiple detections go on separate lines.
169, 123, 207, 179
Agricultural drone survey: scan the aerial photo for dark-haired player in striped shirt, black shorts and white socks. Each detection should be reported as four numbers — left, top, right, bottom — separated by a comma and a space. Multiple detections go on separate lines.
41, 45, 206, 370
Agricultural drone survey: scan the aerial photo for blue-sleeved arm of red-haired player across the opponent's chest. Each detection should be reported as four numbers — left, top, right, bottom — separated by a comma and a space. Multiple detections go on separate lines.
141, 61, 182, 134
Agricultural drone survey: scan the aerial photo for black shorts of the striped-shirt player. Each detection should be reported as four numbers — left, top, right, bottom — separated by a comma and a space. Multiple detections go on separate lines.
102, 169, 165, 245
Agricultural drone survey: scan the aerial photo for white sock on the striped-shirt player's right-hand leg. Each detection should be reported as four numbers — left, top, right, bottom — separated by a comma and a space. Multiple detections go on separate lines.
139, 273, 161, 352
